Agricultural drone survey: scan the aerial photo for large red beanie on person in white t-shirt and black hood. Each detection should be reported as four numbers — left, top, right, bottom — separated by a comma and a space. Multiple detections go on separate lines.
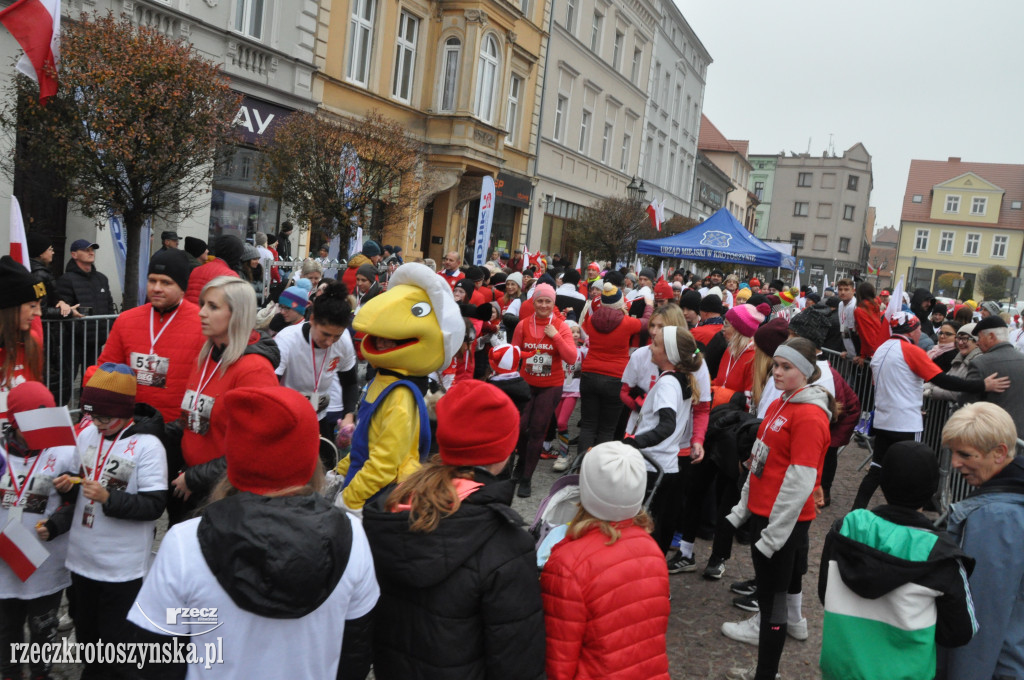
220, 387, 319, 495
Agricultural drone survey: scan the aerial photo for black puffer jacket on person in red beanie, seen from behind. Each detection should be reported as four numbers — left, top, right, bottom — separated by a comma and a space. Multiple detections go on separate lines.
362, 469, 548, 680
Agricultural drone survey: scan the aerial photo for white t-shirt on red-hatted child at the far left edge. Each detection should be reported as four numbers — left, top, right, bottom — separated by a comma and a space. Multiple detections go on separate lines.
0, 447, 78, 600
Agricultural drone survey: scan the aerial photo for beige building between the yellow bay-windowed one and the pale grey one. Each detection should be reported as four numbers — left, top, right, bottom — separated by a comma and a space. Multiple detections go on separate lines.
527, 0, 663, 253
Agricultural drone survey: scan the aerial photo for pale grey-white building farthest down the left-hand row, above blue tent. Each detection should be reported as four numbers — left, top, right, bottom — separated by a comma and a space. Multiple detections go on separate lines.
639, 2, 712, 219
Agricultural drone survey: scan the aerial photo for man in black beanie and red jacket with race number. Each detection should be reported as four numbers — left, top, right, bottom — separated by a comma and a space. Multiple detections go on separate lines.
96, 249, 205, 423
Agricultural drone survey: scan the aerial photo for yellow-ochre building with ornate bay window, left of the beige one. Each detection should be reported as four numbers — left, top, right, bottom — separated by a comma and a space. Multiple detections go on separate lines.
313, 0, 549, 264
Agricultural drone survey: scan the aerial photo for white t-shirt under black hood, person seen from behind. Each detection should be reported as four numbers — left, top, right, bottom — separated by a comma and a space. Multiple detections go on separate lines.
128, 516, 380, 680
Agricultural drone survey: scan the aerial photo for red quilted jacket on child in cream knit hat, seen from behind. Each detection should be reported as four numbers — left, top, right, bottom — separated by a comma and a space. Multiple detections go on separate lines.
541, 519, 670, 680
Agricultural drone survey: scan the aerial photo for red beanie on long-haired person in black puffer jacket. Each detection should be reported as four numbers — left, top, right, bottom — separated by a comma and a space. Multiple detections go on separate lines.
438, 380, 519, 469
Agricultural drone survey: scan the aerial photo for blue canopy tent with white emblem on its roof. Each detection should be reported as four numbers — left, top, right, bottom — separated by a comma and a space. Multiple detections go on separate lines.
637, 208, 793, 269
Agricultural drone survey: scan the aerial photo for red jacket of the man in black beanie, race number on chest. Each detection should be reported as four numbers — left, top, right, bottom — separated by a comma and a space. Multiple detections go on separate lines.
96, 300, 206, 423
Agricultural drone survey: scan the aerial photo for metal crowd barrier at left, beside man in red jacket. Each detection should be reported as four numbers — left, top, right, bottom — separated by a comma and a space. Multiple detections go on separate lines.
43, 314, 118, 413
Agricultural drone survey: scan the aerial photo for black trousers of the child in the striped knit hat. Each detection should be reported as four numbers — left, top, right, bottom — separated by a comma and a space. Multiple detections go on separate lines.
70, 571, 142, 680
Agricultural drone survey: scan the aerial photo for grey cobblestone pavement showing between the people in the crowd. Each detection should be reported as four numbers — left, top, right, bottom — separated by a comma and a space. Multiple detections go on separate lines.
53, 428, 881, 680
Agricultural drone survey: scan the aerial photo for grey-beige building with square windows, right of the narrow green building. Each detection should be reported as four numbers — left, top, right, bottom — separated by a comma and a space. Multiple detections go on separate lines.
766, 142, 872, 288
